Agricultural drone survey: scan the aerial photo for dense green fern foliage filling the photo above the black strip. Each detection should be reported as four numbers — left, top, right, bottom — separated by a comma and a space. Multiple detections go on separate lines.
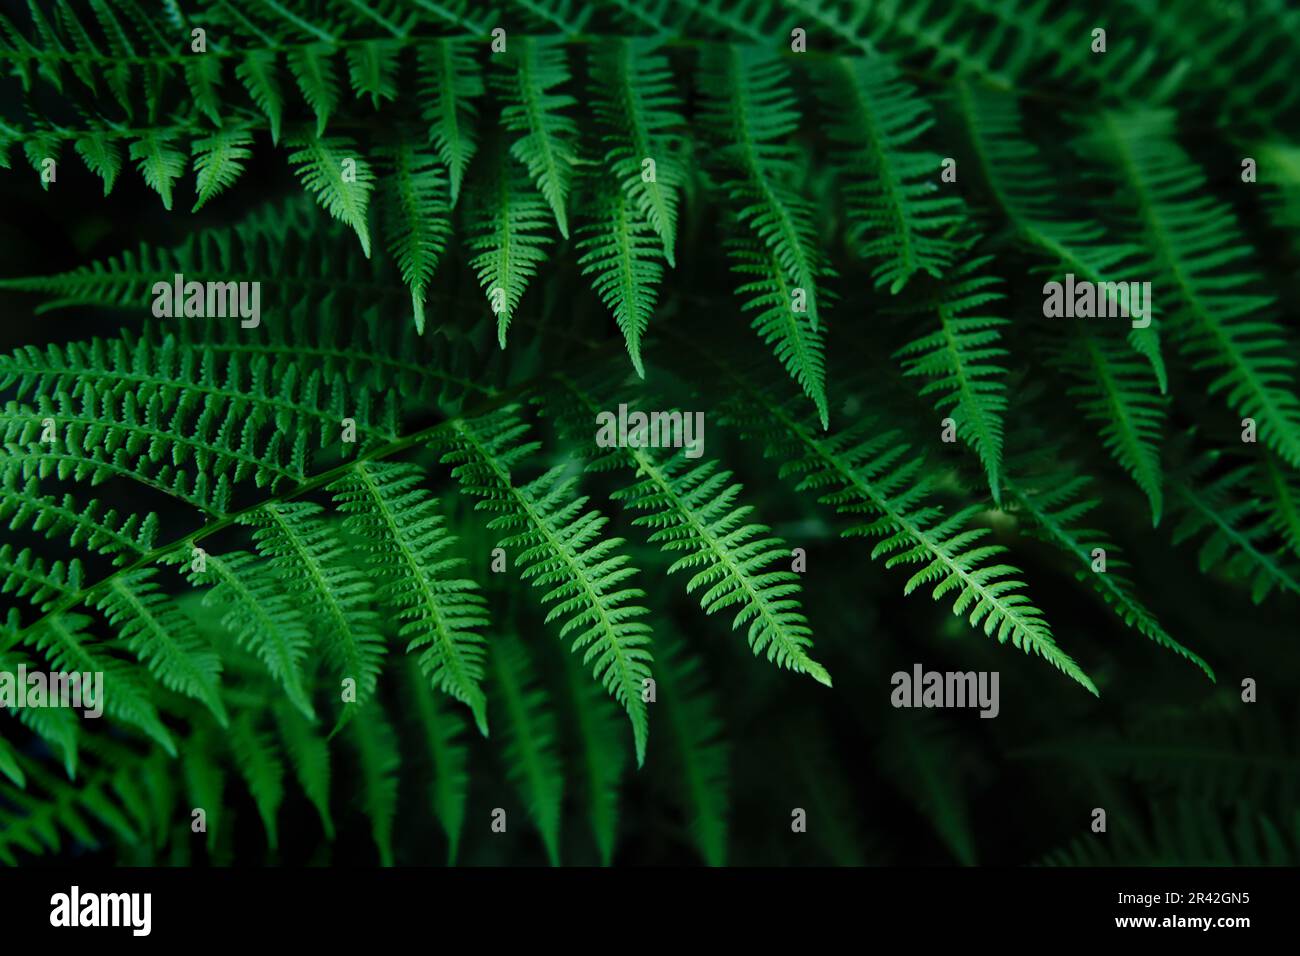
0, 0, 1300, 864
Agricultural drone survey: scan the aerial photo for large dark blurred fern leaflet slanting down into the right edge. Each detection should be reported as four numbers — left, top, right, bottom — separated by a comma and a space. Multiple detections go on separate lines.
1089, 112, 1300, 468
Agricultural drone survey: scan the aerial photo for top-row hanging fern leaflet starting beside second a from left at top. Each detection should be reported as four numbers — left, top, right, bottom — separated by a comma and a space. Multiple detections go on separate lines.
493, 36, 577, 239
